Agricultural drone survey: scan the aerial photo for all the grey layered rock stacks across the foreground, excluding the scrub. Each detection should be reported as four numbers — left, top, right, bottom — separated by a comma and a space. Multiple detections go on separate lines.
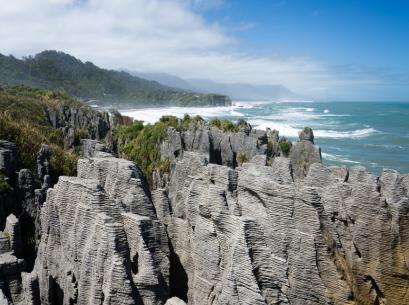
0, 126, 409, 305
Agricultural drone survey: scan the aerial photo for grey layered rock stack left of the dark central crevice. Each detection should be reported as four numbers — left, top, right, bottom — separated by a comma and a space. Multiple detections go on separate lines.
31, 157, 169, 305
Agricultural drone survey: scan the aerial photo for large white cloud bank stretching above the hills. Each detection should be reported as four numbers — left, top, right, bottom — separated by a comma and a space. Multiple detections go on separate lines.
0, 0, 402, 98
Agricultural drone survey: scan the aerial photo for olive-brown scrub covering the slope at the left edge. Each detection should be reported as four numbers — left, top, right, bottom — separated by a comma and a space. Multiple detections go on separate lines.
0, 86, 83, 176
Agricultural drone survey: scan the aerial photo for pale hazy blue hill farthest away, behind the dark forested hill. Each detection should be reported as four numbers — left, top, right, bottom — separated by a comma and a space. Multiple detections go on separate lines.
132, 72, 300, 100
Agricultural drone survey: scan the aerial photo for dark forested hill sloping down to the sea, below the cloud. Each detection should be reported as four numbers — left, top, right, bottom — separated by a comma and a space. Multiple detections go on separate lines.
0, 51, 231, 107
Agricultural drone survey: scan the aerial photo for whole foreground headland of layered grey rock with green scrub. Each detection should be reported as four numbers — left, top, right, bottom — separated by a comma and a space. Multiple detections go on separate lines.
0, 89, 409, 305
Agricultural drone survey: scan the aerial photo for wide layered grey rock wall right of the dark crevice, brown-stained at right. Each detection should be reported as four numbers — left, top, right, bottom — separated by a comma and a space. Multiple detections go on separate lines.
153, 152, 409, 305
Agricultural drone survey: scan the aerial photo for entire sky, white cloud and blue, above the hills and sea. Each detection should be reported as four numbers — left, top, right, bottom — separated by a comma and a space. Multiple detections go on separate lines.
0, 0, 409, 101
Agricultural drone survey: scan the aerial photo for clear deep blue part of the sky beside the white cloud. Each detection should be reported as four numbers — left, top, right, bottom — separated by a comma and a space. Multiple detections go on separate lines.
203, 0, 409, 76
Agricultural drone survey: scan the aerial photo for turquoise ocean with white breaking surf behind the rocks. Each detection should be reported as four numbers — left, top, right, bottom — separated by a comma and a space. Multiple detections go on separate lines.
120, 101, 409, 175
